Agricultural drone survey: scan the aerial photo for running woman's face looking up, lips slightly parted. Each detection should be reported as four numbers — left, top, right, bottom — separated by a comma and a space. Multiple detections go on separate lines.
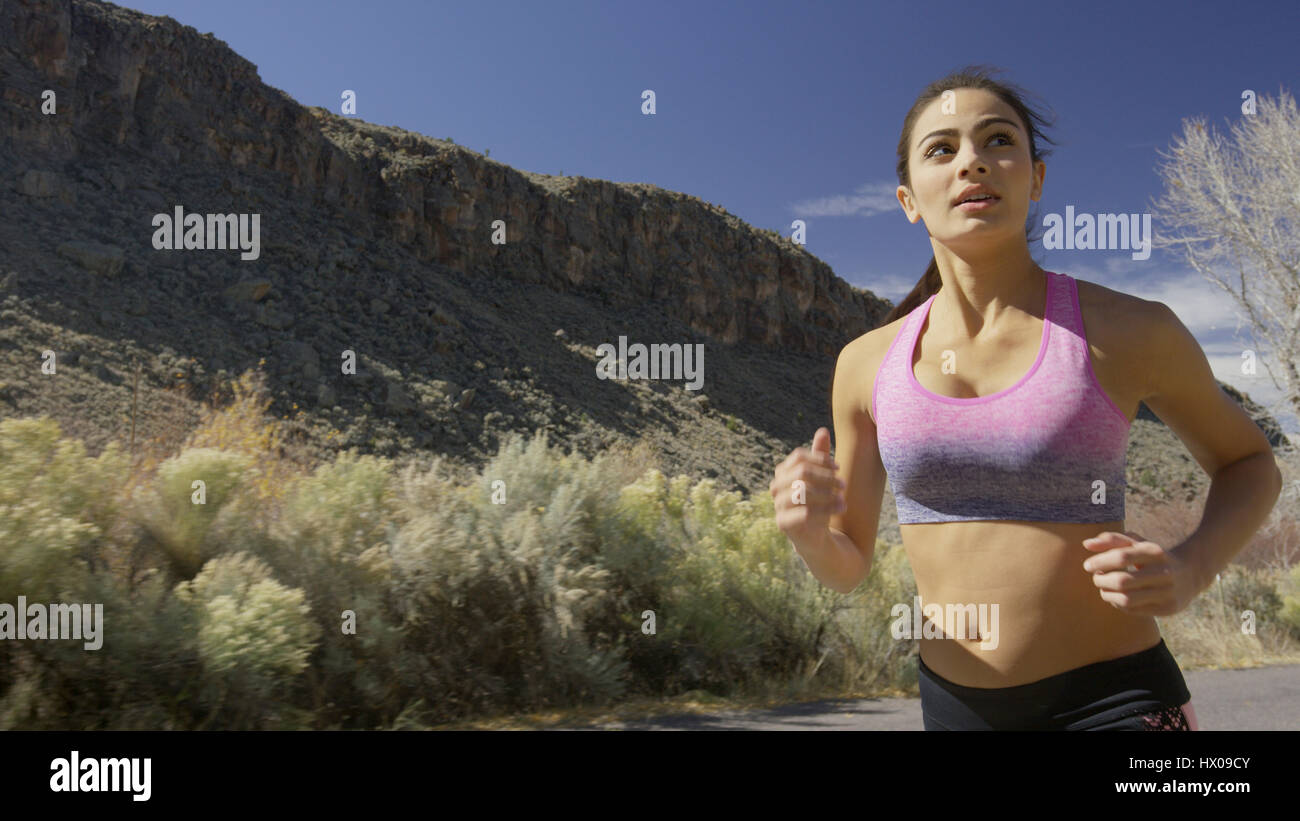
898, 88, 1047, 247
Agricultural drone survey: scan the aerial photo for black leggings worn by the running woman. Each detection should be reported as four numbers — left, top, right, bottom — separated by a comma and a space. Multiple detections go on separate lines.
917, 639, 1196, 730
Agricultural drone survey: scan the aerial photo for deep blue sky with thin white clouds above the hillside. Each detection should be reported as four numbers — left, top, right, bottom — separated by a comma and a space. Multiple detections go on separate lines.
124, 0, 1300, 434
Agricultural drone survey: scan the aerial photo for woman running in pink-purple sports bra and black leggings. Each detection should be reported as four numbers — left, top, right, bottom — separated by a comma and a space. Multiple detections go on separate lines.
771, 69, 1282, 730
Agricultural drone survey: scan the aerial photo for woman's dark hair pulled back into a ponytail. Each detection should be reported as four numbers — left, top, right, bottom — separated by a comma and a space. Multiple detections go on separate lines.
880, 65, 1052, 326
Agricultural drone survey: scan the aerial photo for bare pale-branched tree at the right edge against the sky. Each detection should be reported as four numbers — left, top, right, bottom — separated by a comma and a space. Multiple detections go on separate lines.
1152, 91, 1300, 436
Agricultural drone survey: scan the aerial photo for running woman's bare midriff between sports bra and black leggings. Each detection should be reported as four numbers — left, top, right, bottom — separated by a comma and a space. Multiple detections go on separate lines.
898, 521, 1160, 687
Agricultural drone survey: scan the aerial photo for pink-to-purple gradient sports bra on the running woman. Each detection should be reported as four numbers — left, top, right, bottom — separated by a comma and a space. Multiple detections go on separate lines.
871, 272, 1131, 525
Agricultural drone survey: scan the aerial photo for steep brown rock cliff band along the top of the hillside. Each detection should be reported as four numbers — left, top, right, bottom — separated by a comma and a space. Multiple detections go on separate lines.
0, 0, 889, 355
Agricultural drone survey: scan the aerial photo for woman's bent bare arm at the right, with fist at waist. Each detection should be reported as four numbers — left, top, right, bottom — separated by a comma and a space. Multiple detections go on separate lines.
1084, 301, 1282, 614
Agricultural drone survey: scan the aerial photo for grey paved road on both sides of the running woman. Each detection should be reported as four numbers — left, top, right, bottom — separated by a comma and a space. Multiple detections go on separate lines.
569, 665, 1300, 730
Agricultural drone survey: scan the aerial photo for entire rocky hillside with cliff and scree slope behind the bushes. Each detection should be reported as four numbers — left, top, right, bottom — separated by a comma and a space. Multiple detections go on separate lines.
0, 0, 1275, 548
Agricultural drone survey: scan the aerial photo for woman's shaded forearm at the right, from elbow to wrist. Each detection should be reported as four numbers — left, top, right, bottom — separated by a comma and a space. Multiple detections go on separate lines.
1171, 452, 1282, 592
